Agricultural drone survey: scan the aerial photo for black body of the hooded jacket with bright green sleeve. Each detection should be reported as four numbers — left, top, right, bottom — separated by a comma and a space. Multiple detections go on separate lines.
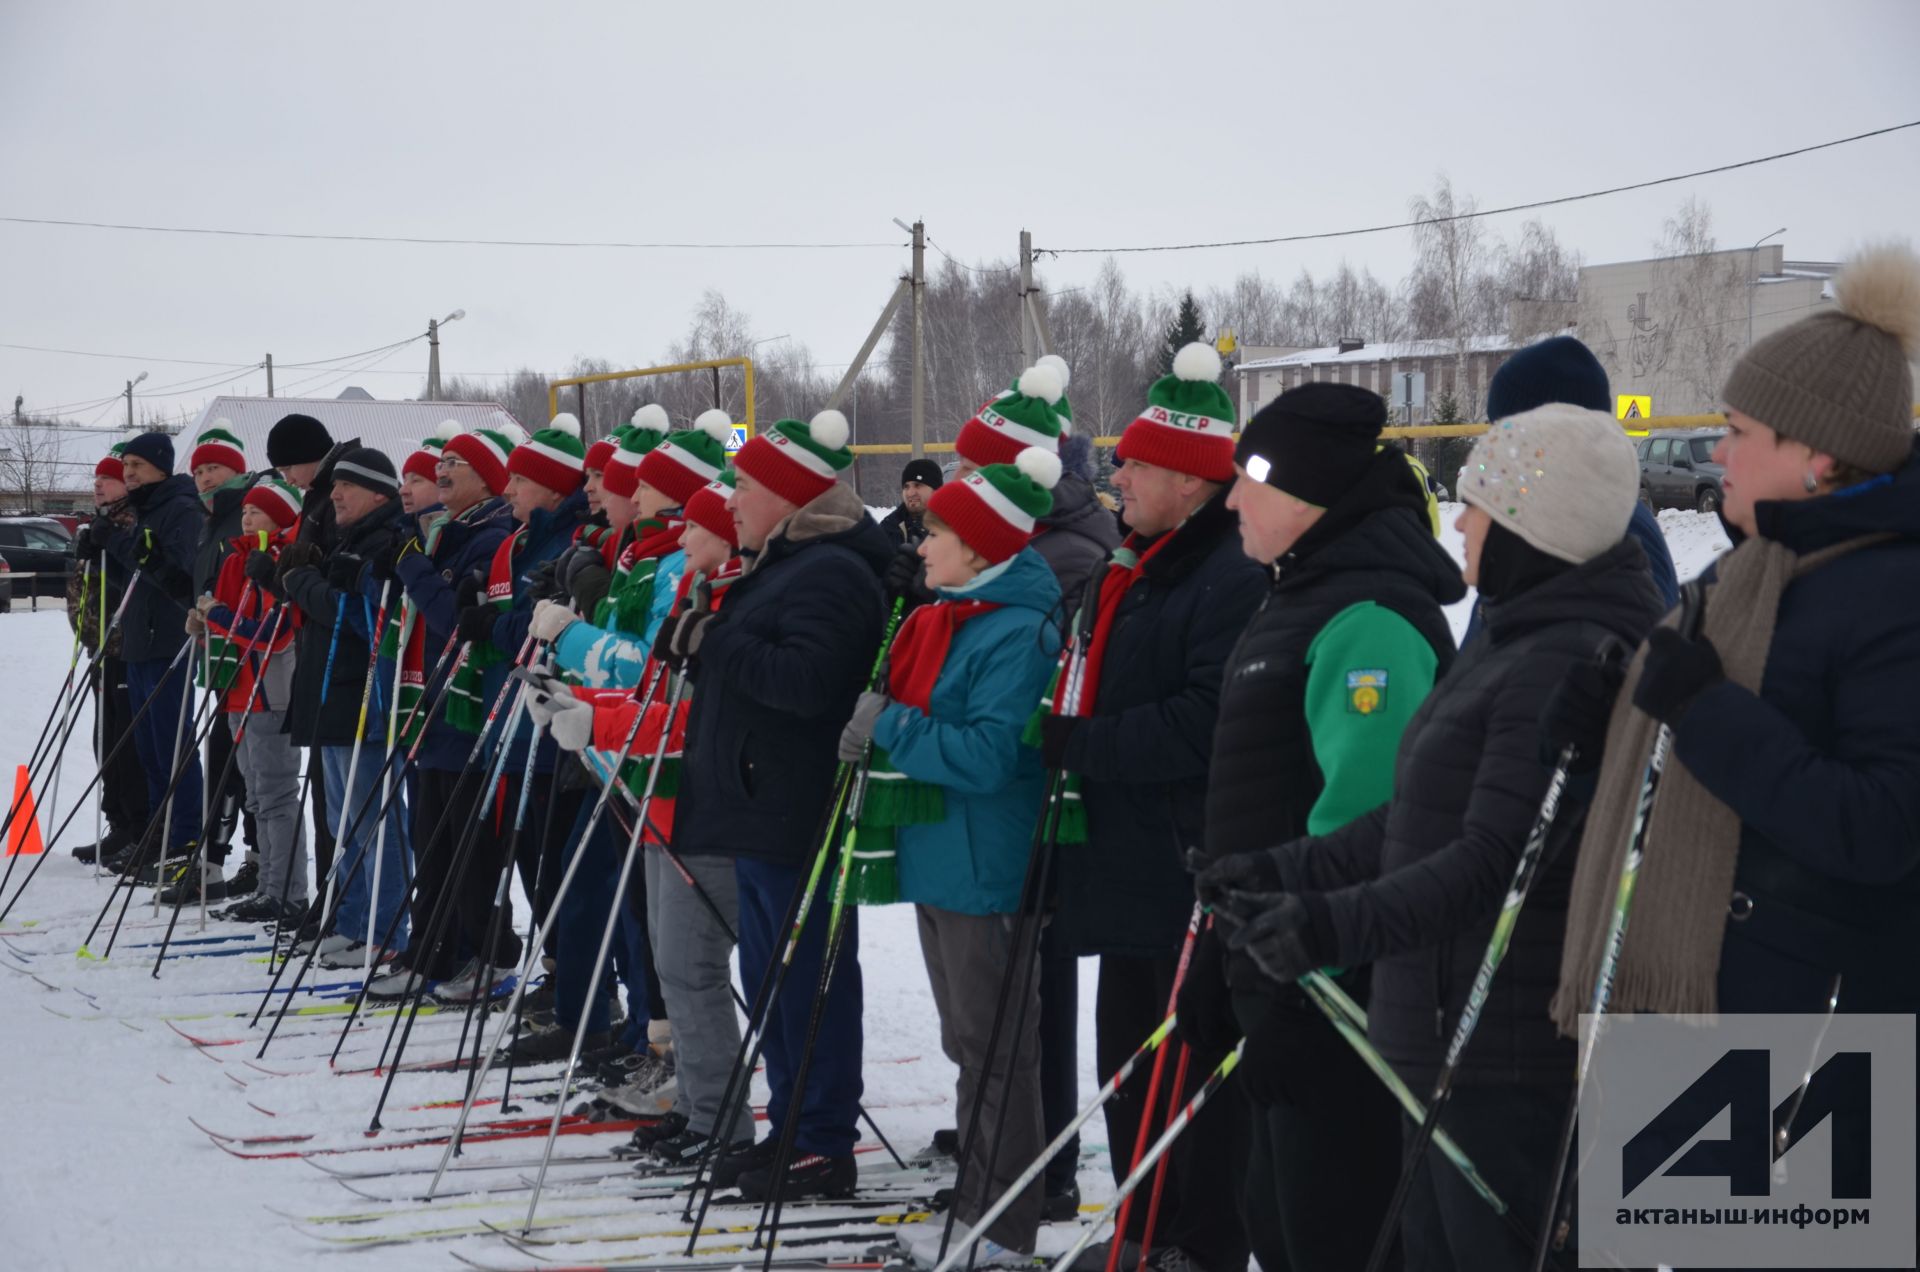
1206, 448, 1467, 857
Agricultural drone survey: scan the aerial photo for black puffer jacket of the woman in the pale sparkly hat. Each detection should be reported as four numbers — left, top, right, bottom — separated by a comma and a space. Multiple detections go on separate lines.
1281, 538, 1661, 1086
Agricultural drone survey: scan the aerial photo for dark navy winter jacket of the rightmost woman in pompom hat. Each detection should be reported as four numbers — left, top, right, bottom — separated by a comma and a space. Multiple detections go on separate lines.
1681, 443, 1920, 1013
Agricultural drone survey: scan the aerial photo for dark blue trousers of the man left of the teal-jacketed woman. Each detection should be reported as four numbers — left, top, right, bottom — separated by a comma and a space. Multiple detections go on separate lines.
733, 857, 864, 1157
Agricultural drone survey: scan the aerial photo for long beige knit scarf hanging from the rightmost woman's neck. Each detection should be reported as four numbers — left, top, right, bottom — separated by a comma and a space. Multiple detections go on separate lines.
1551, 534, 1891, 1038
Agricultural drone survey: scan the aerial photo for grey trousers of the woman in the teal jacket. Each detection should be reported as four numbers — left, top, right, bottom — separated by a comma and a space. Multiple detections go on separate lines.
917, 905, 1046, 1253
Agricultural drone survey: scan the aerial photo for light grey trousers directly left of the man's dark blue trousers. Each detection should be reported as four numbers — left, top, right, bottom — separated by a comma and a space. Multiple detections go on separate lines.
643, 845, 753, 1143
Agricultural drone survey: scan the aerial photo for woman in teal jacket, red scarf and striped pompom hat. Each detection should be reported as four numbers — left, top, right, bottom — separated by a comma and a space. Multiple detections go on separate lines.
841, 448, 1060, 1266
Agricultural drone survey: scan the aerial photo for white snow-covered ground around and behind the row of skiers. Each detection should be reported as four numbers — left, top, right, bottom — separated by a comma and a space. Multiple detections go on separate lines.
0, 505, 1726, 1272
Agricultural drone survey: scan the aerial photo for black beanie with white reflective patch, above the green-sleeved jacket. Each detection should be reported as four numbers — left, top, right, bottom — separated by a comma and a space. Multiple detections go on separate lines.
1233, 382, 1386, 507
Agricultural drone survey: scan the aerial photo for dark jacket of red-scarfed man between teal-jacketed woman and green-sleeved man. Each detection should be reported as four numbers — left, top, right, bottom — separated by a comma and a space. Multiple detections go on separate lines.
1054, 490, 1267, 957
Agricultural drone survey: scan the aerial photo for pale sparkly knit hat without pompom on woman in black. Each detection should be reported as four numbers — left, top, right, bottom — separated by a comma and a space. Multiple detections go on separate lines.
1459, 402, 1640, 565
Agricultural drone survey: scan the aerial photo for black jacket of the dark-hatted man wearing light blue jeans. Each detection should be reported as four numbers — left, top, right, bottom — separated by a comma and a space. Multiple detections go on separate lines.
284, 498, 399, 746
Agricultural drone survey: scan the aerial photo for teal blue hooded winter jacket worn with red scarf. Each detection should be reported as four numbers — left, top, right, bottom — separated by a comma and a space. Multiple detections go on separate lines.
874, 548, 1060, 915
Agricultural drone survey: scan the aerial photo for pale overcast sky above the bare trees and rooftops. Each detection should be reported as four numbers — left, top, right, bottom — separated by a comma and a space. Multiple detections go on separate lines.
0, 0, 1920, 434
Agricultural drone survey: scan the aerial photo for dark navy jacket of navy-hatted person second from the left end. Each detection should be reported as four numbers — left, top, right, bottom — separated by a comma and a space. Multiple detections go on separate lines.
108, 473, 205, 663
